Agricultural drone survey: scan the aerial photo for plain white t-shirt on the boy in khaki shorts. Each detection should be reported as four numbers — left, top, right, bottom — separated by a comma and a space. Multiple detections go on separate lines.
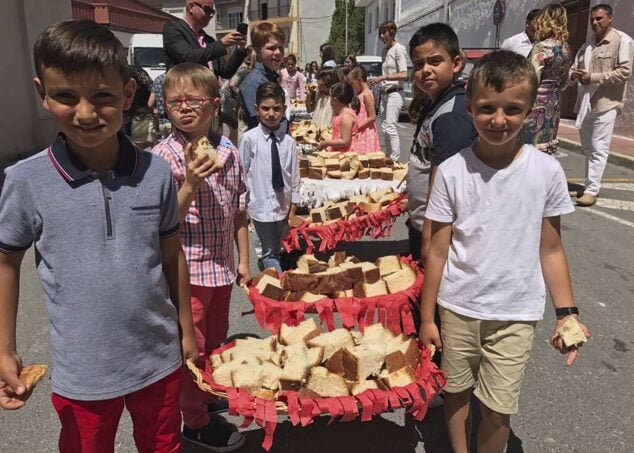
425, 145, 574, 321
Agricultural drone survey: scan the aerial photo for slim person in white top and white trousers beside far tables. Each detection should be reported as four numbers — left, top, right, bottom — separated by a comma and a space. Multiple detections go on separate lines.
368, 20, 407, 161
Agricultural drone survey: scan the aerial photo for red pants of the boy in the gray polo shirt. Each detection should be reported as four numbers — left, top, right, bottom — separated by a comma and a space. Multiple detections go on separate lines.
51, 369, 183, 453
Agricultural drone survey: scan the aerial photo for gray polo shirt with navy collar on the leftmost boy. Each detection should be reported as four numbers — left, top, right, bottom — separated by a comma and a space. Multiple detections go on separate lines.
0, 134, 181, 400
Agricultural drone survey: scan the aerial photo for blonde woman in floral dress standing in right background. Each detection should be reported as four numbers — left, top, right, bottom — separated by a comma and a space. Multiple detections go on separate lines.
524, 3, 572, 154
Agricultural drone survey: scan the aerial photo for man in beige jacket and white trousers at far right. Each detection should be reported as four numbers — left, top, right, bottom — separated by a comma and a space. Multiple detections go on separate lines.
570, 3, 634, 206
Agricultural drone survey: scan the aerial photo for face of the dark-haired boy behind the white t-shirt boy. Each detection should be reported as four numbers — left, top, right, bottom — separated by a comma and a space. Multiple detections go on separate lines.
411, 41, 462, 99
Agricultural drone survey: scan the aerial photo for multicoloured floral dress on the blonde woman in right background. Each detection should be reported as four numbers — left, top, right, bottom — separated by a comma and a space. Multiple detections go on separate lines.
524, 38, 573, 154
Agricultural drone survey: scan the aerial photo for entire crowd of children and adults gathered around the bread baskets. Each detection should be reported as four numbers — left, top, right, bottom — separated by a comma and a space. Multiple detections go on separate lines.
0, 0, 632, 453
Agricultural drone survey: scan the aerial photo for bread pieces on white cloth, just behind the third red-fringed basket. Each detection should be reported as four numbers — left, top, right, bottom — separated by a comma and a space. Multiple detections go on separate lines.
299, 151, 407, 182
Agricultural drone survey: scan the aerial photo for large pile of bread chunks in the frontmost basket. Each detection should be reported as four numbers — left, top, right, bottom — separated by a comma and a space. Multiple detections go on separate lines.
210, 318, 420, 399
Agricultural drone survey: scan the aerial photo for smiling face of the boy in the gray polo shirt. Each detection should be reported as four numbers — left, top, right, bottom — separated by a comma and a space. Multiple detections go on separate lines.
34, 68, 136, 154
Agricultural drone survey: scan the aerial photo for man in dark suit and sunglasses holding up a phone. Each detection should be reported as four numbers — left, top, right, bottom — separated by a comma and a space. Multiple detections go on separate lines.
163, 0, 246, 79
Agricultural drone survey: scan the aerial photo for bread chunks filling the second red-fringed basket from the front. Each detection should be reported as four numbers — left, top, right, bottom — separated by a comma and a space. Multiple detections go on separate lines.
254, 252, 417, 303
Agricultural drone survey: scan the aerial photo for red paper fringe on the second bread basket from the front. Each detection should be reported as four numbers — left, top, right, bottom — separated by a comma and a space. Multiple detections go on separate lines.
249, 257, 423, 335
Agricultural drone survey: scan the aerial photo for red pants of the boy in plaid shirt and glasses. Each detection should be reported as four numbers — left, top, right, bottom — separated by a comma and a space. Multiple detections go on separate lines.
180, 285, 233, 429
